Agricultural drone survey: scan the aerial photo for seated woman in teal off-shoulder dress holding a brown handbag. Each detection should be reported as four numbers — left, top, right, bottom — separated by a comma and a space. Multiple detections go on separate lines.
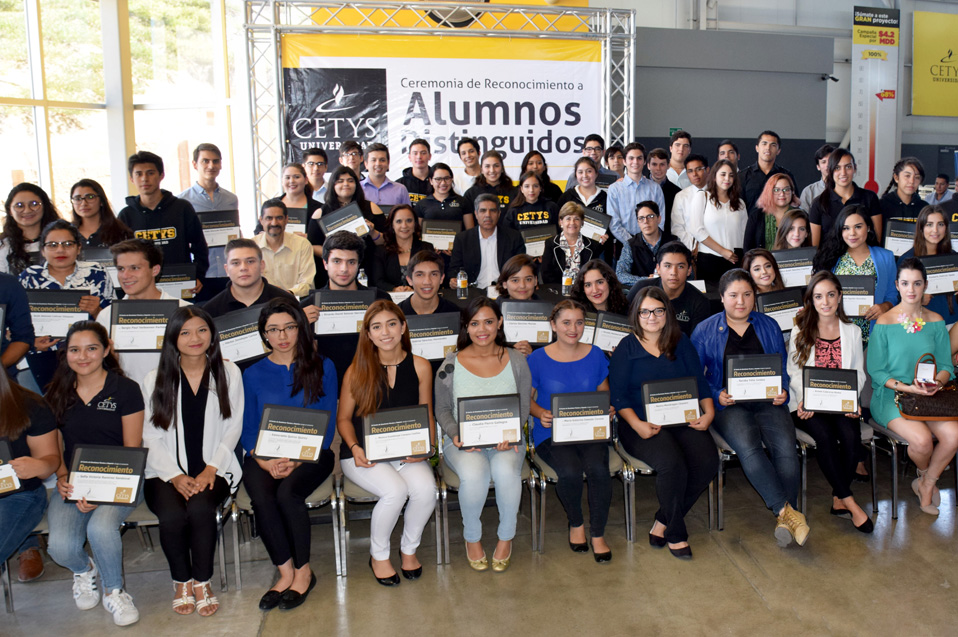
867, 257, 958, 515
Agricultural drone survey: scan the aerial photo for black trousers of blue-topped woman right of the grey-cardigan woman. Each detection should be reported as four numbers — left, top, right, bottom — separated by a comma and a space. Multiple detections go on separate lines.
536, 438, 612, 537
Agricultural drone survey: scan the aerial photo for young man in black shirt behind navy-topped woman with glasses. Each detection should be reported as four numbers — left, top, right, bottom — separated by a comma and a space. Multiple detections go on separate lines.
629, 241, 710, 337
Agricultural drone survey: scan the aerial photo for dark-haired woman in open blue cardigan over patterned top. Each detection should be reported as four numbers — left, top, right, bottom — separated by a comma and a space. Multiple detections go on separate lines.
812, 204, 898, 347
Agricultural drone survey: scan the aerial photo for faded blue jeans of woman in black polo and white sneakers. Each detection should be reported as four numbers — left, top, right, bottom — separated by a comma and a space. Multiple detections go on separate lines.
47, 489, 143, 592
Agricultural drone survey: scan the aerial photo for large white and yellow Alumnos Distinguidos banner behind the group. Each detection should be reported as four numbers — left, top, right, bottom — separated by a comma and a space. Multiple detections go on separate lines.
282, 35, 603, 180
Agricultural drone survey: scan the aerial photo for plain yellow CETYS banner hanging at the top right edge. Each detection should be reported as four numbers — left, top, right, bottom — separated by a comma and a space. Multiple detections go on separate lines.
911, 11, 958, 117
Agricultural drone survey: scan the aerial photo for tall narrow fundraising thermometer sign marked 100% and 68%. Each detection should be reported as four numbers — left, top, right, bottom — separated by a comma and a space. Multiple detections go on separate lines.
851, 7, 900, 192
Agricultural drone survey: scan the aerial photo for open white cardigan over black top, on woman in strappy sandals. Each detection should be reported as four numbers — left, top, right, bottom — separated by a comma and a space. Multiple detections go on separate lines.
143, 361, 244, 490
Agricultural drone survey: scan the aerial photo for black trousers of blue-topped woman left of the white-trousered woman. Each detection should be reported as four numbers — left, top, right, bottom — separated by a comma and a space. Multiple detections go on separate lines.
243, 449, 335, 568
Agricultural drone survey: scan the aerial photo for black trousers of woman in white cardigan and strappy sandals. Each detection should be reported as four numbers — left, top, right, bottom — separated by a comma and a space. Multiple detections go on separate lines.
143, 476, 230, 582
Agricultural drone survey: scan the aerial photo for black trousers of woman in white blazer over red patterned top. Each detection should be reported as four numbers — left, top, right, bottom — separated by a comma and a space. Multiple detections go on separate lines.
792, 412, 874, 499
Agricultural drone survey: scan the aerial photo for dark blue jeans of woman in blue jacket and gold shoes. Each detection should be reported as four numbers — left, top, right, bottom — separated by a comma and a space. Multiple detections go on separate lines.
712, 402, 801, 514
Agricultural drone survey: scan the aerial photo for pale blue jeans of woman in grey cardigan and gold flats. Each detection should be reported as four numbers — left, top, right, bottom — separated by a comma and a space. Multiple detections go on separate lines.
442, 437, 526, 542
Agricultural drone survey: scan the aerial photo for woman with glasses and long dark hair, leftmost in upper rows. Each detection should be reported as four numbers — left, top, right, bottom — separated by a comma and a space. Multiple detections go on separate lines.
0, 183, 60, 276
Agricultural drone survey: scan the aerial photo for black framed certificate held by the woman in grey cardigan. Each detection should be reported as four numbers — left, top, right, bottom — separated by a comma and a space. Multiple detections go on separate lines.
458, 394, 522, 449
